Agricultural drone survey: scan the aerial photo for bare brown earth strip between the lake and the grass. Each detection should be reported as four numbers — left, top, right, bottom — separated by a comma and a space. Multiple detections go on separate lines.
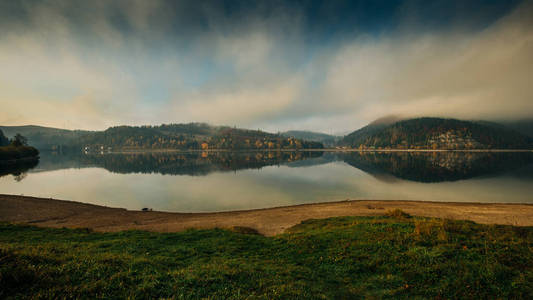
0, 195, 533, 236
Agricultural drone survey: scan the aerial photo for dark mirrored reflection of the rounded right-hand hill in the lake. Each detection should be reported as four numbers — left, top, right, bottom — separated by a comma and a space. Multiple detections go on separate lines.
342, 152, 533, 182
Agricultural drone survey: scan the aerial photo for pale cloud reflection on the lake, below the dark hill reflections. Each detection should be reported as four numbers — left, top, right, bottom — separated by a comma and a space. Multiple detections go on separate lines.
0, 156, 533, 212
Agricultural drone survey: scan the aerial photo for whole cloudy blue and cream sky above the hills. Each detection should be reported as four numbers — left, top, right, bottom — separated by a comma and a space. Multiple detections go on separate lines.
0, 0, 533, 134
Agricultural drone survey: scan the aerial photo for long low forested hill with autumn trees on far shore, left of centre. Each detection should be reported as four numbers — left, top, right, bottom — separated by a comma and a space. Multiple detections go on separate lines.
0, 123, 323, 151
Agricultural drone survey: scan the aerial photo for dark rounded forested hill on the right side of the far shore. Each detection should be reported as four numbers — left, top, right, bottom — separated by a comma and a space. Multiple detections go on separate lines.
341, 118, 533, 149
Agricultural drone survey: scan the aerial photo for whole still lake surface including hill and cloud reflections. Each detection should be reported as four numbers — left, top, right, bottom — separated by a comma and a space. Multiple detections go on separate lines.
0, 152, 533, 212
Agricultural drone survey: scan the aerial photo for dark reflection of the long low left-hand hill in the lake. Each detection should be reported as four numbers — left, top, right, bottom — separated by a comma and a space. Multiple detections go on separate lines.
36, 151, 323, 175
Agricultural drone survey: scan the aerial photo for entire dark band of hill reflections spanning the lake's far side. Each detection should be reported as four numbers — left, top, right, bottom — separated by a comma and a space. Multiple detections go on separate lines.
31, 151, 533, 182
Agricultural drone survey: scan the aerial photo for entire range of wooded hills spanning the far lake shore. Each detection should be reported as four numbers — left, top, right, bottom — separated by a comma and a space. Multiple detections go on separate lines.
4, 116, 533, 151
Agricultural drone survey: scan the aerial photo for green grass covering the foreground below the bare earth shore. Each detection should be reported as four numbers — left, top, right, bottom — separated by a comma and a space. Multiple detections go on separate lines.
0, 215, 533, 299
